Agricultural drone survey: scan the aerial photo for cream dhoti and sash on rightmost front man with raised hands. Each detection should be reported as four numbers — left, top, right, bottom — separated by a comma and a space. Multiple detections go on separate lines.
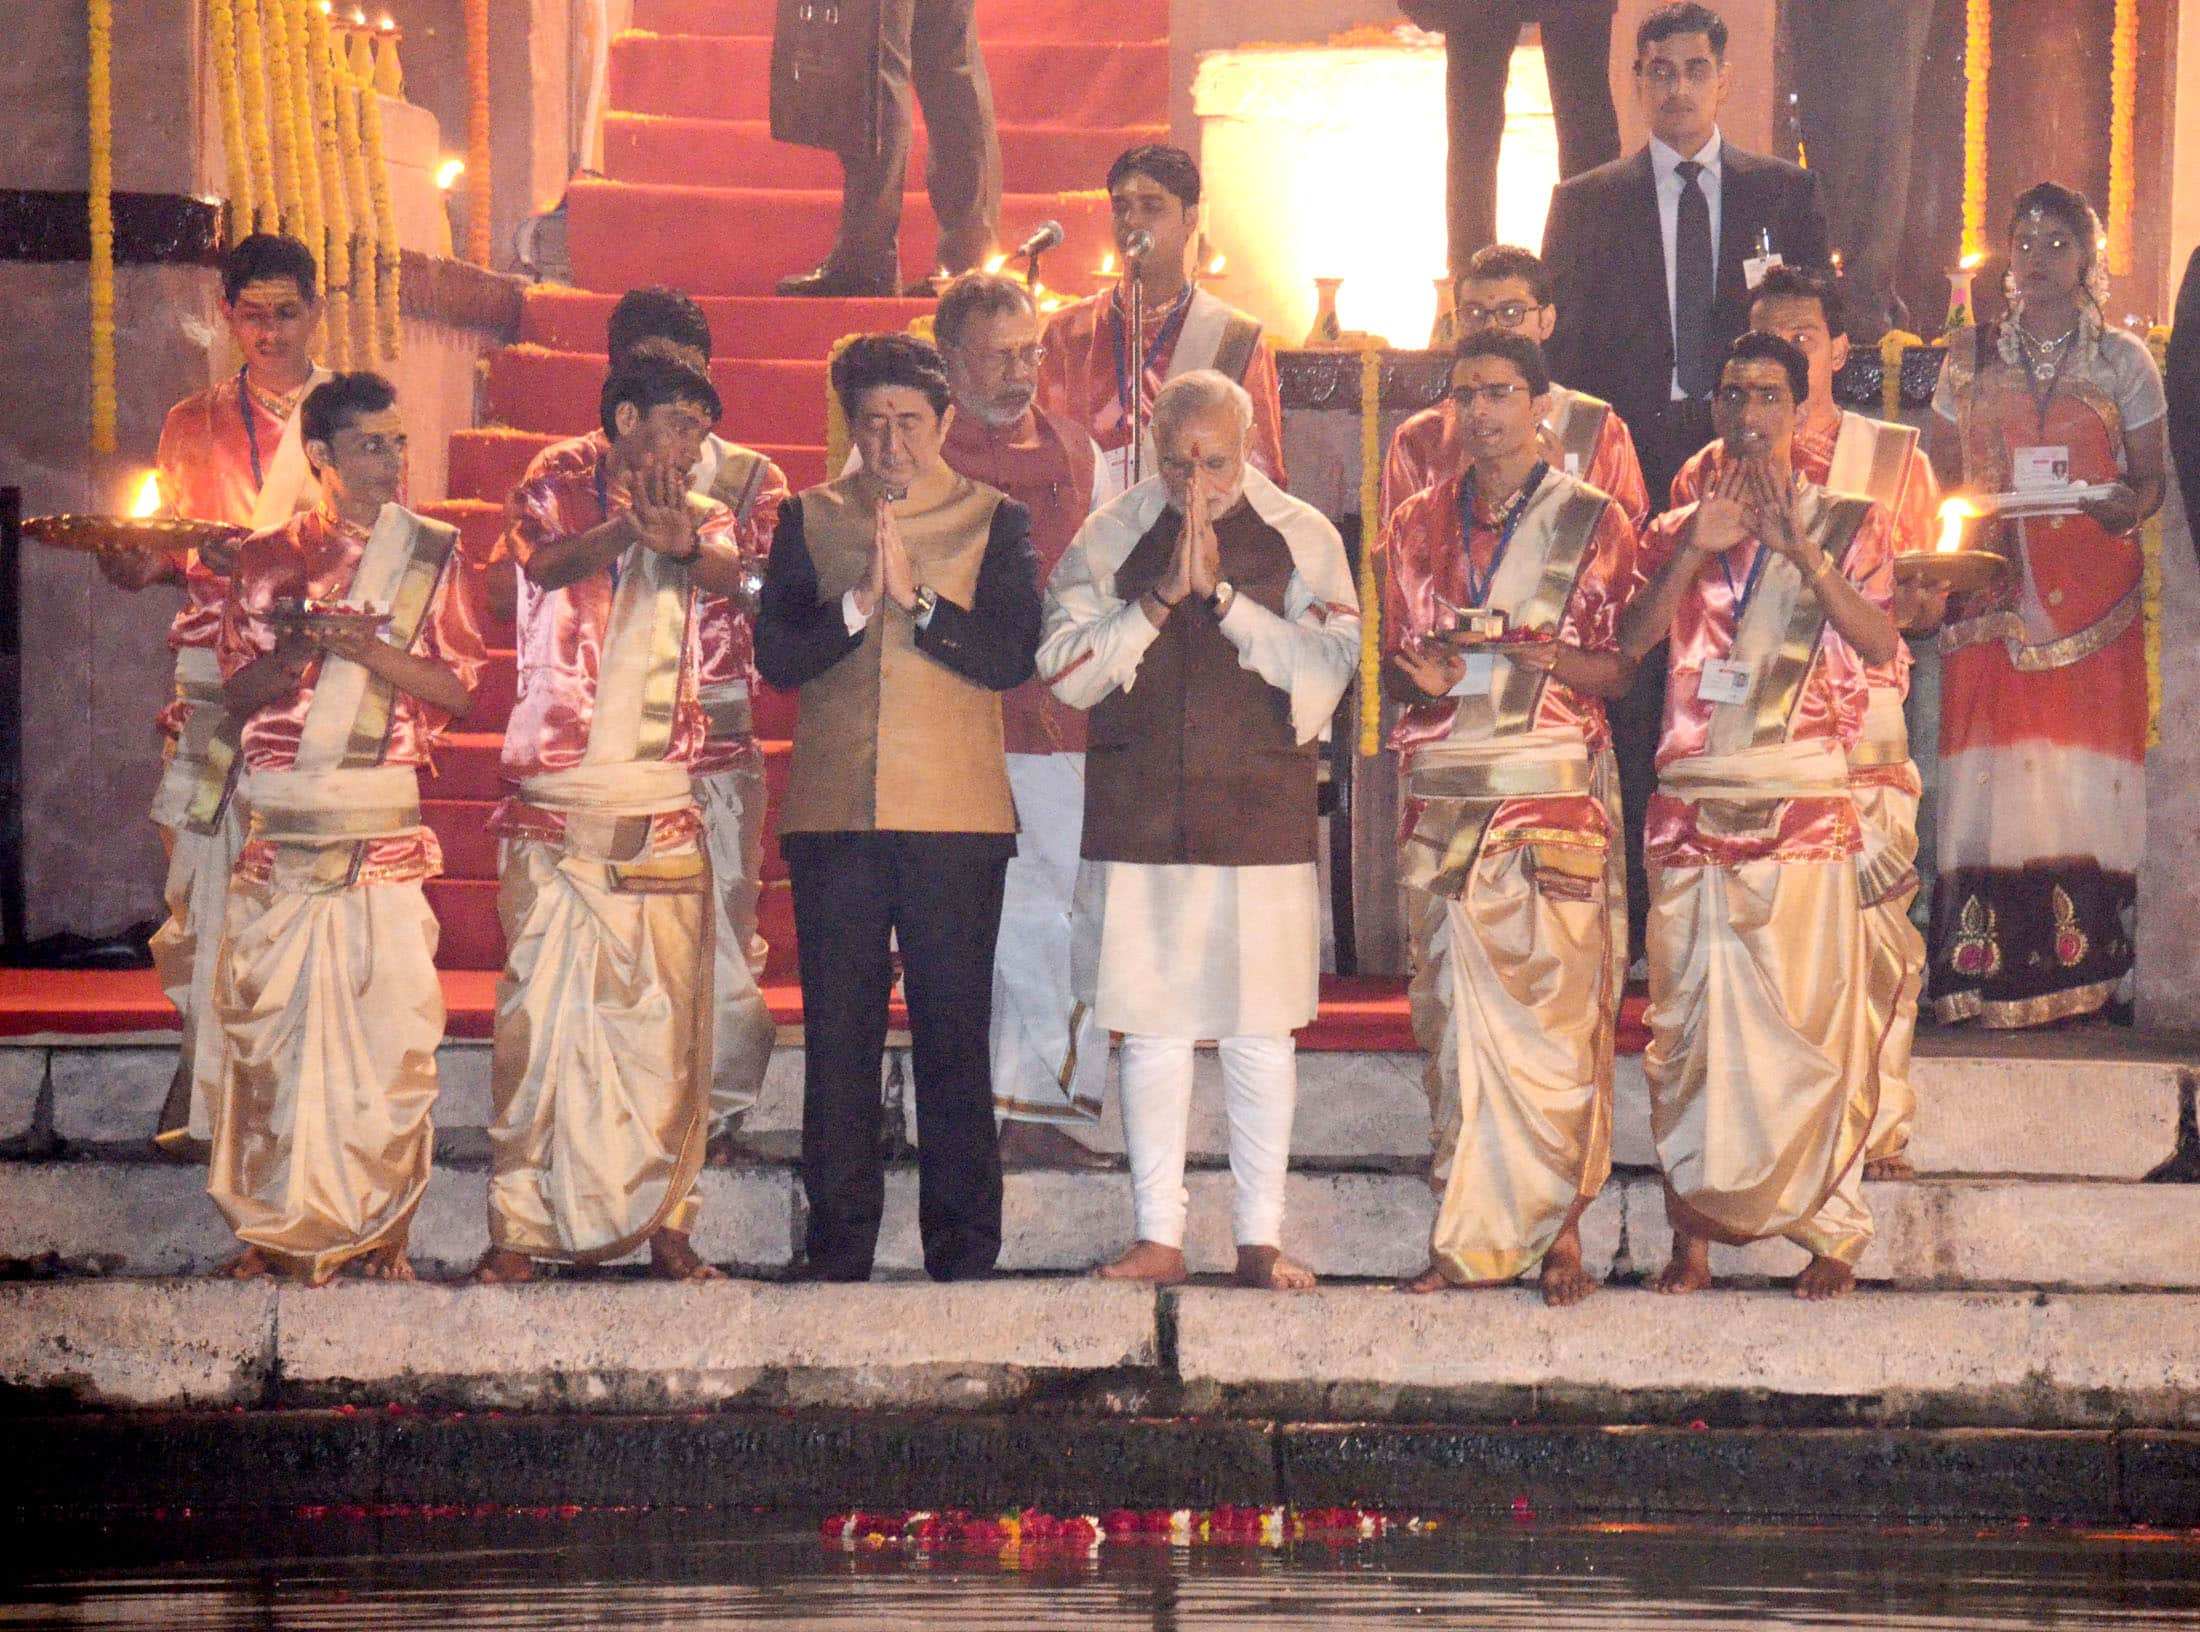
1643, 739, 1879, 1265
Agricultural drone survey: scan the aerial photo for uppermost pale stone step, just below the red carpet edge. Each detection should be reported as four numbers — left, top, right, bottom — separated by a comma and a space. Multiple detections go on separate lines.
30, 1045, 2191, 1179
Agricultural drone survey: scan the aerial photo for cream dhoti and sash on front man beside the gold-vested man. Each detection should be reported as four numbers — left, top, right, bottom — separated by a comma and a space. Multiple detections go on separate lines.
488, 761, 711, 1262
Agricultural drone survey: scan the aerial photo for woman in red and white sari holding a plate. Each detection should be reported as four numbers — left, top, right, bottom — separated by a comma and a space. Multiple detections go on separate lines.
1932, 183, 2167, 1027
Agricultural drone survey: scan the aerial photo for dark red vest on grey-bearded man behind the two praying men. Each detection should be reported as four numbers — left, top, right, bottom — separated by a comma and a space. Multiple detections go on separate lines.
939, 409, 1098, 754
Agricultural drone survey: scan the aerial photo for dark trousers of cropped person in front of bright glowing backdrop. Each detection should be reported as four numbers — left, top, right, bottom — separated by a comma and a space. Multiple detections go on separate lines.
1443, 0, 1619, 277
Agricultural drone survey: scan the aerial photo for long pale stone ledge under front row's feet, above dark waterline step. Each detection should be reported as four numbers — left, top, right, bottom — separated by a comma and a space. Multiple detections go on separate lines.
0, 1280, 2200, 1434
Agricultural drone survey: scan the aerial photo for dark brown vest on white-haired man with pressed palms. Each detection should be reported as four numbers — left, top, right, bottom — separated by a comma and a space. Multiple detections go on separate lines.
1085, 504, 1316, 867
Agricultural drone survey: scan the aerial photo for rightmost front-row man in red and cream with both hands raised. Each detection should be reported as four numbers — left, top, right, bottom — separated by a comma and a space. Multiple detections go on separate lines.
1621, 332, 1899, 1298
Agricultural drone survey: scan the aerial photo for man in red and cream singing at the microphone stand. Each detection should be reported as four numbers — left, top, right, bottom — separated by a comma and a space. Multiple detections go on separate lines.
1038, 143, 1285, 488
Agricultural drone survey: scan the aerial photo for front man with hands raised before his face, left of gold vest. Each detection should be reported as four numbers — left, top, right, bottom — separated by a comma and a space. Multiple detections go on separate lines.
475, 354, 744, 1280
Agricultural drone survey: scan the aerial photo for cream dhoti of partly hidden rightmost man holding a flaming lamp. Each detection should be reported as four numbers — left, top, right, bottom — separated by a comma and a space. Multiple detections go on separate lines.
1848, 686, 1925, 1161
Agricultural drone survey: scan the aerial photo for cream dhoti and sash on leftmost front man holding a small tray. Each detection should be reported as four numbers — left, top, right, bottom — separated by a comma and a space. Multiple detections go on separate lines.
207, 765, 444, 1282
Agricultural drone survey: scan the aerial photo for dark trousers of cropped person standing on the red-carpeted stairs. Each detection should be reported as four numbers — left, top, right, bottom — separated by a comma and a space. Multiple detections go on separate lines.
832, 0, 1001, 275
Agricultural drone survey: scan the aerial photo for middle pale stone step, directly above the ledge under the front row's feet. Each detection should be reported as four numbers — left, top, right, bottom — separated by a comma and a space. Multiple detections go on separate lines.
17, 1159, 2200, 1289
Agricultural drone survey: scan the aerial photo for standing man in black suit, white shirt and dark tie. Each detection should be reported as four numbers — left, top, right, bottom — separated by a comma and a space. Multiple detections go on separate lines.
1542, 4, 1826, 955
